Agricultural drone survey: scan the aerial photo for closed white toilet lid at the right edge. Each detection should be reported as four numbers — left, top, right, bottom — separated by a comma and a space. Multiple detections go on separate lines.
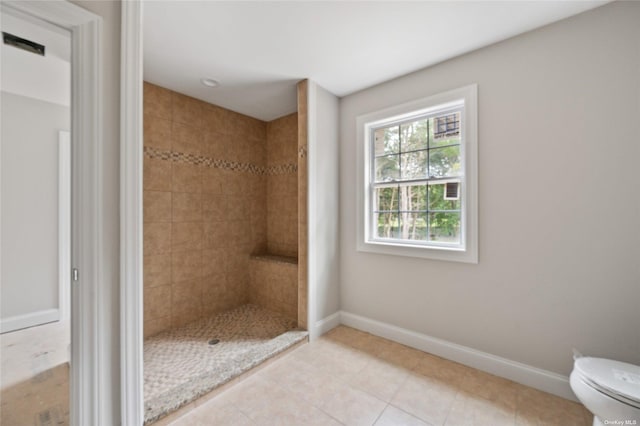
574, 357, 640, 401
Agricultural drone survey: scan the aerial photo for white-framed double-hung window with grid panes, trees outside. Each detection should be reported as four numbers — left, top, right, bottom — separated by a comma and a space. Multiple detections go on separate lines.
358, 85, 477, 263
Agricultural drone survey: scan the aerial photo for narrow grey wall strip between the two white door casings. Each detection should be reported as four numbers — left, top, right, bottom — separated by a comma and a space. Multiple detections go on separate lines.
73, 0, 120, 425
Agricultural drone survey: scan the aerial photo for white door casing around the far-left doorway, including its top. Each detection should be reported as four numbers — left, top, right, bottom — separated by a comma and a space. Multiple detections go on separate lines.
2, 0, 104, 425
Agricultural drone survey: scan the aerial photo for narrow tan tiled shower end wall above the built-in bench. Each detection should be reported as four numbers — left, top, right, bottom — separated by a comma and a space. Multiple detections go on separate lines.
267, 113, 298, 257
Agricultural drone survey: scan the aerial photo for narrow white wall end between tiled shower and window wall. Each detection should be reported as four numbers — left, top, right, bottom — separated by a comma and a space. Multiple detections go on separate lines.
307, 81, 340, 338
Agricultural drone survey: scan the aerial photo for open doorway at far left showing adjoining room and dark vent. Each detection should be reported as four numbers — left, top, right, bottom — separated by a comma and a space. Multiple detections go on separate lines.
0, 9, 71, 424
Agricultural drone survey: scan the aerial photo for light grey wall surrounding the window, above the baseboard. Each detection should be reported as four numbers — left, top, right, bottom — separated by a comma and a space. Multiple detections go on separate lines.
340, 2, 640, 375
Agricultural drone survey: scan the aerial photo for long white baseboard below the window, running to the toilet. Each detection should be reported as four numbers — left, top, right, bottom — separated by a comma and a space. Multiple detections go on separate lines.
340, 311, 577, 401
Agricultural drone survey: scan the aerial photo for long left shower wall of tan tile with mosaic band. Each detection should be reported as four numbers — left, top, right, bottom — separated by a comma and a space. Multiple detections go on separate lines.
144, 83, 267, 336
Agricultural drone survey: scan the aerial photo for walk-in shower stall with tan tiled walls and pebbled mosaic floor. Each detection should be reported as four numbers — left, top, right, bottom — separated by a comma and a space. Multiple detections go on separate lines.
143, 81, 307, 423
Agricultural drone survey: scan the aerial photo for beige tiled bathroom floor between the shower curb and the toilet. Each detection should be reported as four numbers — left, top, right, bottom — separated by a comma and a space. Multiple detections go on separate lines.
156, 326, 592, 426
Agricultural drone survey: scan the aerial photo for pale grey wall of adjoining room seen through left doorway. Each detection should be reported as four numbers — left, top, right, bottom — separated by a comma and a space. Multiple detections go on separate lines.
0, 91, 70, 331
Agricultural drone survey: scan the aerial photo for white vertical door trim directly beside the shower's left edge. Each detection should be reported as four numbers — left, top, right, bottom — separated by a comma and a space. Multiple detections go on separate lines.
120, 0, 144, 425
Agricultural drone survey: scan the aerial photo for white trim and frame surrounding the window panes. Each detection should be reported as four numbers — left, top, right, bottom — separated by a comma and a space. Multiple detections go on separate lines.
356, 84, 478, 263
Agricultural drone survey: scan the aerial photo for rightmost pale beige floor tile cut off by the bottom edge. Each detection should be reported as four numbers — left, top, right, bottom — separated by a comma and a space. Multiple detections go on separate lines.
445, 392, 515, 426
